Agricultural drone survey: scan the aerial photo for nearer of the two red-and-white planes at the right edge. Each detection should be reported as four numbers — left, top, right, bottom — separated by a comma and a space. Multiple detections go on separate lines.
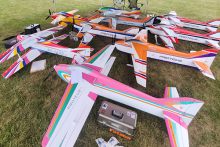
146, 19, 220, 50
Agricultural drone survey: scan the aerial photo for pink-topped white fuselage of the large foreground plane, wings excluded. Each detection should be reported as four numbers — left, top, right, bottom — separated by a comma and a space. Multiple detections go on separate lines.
55, 65, 201, 125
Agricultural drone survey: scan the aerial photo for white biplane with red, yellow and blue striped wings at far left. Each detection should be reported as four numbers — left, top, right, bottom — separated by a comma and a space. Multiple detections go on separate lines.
0, 26, 90, 78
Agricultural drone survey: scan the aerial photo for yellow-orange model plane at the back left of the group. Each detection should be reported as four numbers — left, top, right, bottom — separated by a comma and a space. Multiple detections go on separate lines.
46, 10, 99, 26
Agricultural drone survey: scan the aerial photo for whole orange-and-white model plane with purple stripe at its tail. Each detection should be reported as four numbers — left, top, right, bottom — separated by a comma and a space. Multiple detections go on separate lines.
115, 30, 218, 87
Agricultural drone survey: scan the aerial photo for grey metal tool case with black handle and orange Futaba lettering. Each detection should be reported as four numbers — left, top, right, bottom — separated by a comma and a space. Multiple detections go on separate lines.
98, 101, 137, 140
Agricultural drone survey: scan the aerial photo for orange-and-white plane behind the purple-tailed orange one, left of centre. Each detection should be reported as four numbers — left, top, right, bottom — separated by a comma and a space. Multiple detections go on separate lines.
74, 22, 139, 46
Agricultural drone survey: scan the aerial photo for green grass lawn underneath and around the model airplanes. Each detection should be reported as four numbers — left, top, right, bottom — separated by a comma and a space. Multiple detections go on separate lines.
0, 0, 220, 147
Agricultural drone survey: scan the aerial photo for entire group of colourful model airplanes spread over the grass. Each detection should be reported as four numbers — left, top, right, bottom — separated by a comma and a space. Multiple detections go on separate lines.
0, 7, 220, 147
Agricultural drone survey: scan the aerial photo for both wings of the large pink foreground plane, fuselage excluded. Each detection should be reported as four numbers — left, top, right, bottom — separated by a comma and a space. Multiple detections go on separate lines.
42, 45, 114, 147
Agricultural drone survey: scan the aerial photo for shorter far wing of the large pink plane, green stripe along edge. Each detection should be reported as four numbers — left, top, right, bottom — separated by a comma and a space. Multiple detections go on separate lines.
82, 45, 115, 72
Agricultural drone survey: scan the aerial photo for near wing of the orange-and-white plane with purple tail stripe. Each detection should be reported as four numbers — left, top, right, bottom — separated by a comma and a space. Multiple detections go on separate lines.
132, 42, 147, 87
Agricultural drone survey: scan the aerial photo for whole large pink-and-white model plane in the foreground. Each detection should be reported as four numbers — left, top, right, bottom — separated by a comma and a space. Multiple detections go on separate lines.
42, 45, 204, 147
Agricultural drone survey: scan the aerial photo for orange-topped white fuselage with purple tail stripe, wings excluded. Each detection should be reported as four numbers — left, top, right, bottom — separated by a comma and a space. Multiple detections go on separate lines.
115, 41, 216, 70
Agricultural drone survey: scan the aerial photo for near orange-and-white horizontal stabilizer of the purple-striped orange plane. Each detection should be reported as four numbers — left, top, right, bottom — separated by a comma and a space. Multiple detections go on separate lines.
193, 60, 215, 80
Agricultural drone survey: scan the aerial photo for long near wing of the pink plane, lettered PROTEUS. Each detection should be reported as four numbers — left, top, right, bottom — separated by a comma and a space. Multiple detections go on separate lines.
42, 78, 98, 147
